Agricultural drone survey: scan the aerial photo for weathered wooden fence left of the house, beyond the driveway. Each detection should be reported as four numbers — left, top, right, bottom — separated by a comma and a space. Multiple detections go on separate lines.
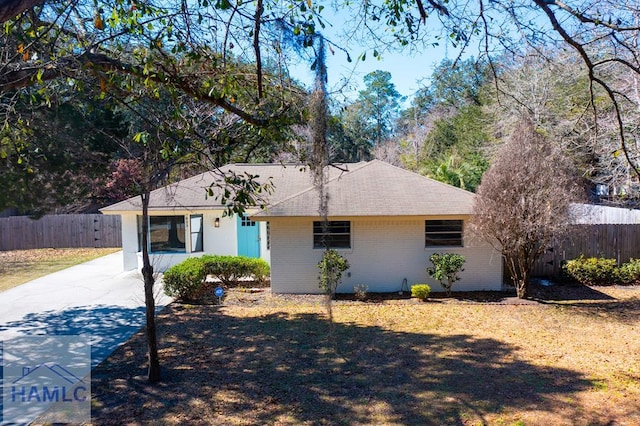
0, 214, 122, 250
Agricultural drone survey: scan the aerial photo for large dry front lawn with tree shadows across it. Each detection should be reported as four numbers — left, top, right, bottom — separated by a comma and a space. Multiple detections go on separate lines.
92, 287, 640, 425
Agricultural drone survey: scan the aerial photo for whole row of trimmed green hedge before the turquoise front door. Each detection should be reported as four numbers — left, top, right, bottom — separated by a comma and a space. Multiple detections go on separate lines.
164, 255, 270, 300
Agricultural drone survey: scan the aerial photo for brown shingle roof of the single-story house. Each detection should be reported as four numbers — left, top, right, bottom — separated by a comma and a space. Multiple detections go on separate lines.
102, 160, 474, 218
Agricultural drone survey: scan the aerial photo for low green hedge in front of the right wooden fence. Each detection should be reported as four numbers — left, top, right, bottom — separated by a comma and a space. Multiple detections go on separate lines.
564, 256, 640, 285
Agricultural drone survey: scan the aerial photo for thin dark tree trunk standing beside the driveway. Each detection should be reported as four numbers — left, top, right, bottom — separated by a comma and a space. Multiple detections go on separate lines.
141, 189, 160, 383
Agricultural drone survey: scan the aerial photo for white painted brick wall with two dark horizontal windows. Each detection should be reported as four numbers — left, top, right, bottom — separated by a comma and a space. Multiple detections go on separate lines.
271, 217, 502, 293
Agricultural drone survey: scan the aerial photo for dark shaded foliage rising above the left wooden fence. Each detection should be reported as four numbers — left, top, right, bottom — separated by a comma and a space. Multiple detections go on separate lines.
0, 93, 124, 215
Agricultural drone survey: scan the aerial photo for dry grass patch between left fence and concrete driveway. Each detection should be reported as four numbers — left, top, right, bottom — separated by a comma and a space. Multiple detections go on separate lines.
0, 248, 121, 291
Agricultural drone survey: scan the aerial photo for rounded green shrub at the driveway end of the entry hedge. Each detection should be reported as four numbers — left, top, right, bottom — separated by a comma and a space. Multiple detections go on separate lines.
163, 257, 207, 300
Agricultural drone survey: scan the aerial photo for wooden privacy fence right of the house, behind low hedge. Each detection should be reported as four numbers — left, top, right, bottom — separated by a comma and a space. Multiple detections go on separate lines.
532, 224, 640, 278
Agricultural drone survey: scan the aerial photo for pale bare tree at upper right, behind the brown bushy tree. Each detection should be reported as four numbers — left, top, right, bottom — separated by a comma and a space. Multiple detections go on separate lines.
487, 49, 640, 205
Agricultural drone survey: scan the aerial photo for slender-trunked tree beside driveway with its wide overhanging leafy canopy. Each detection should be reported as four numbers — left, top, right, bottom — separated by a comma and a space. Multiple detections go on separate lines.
0, 0, 306, 382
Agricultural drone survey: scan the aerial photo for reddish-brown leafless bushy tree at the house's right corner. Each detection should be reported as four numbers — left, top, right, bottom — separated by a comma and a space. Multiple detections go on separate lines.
472, 118, 580, 298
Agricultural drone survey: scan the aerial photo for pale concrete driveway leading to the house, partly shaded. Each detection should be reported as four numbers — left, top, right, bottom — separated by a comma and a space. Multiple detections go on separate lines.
0, 252, 171, 367
